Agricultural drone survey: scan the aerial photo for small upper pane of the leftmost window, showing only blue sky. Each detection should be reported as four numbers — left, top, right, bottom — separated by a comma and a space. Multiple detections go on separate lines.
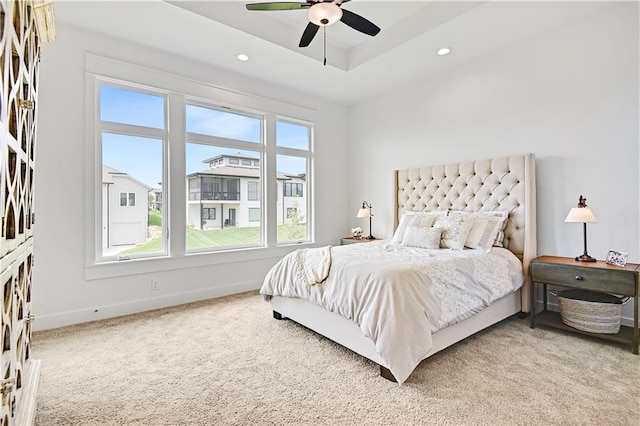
100, 85, 165, 129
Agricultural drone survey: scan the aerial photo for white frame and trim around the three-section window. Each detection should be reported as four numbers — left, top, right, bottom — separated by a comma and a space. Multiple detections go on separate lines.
84, 53, 318, 280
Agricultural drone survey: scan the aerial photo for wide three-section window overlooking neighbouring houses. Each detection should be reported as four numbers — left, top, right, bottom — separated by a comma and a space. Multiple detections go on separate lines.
92, 72, 313, 269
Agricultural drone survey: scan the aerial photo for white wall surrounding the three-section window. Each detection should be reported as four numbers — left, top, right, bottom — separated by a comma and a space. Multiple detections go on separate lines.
33, 24, 348, 329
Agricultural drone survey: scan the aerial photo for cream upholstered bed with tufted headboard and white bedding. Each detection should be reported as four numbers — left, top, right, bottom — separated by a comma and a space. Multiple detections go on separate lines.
261, 154, 536, 383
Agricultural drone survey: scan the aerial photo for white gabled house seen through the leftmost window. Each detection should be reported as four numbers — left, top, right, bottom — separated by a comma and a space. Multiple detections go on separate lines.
102, 166, 152, 248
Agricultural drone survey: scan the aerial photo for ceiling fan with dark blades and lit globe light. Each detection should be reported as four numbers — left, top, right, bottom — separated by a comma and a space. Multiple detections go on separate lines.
247, 0, 380, 47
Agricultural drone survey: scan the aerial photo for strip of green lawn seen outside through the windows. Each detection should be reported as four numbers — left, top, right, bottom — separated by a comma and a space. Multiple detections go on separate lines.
121, 225, 307, 254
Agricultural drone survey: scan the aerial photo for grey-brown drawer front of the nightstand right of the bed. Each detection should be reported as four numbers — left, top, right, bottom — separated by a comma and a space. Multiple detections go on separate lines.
531, 261, 636, 296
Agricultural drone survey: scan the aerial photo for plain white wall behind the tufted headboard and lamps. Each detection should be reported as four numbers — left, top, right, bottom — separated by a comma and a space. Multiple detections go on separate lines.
348, 2, 640, 316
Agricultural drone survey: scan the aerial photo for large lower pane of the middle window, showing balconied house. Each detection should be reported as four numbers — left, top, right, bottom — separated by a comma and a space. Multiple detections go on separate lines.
186, 142, 262, 250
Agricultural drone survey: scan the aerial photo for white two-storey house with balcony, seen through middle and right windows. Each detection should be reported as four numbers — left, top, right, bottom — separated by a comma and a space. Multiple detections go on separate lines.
187, 154, 307, 229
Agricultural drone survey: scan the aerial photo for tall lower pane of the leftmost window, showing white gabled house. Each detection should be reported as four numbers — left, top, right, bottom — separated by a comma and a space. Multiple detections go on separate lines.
101, 133, 165, 257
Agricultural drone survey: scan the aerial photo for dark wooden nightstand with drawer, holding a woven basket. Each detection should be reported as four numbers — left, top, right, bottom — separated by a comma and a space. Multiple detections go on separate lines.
531, 256, 640, 354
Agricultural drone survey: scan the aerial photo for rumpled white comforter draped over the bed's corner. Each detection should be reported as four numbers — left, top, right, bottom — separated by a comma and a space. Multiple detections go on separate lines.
260, 240, 523, 383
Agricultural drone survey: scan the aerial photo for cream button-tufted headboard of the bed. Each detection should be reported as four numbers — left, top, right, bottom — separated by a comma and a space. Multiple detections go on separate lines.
394, 154, 536, 311
